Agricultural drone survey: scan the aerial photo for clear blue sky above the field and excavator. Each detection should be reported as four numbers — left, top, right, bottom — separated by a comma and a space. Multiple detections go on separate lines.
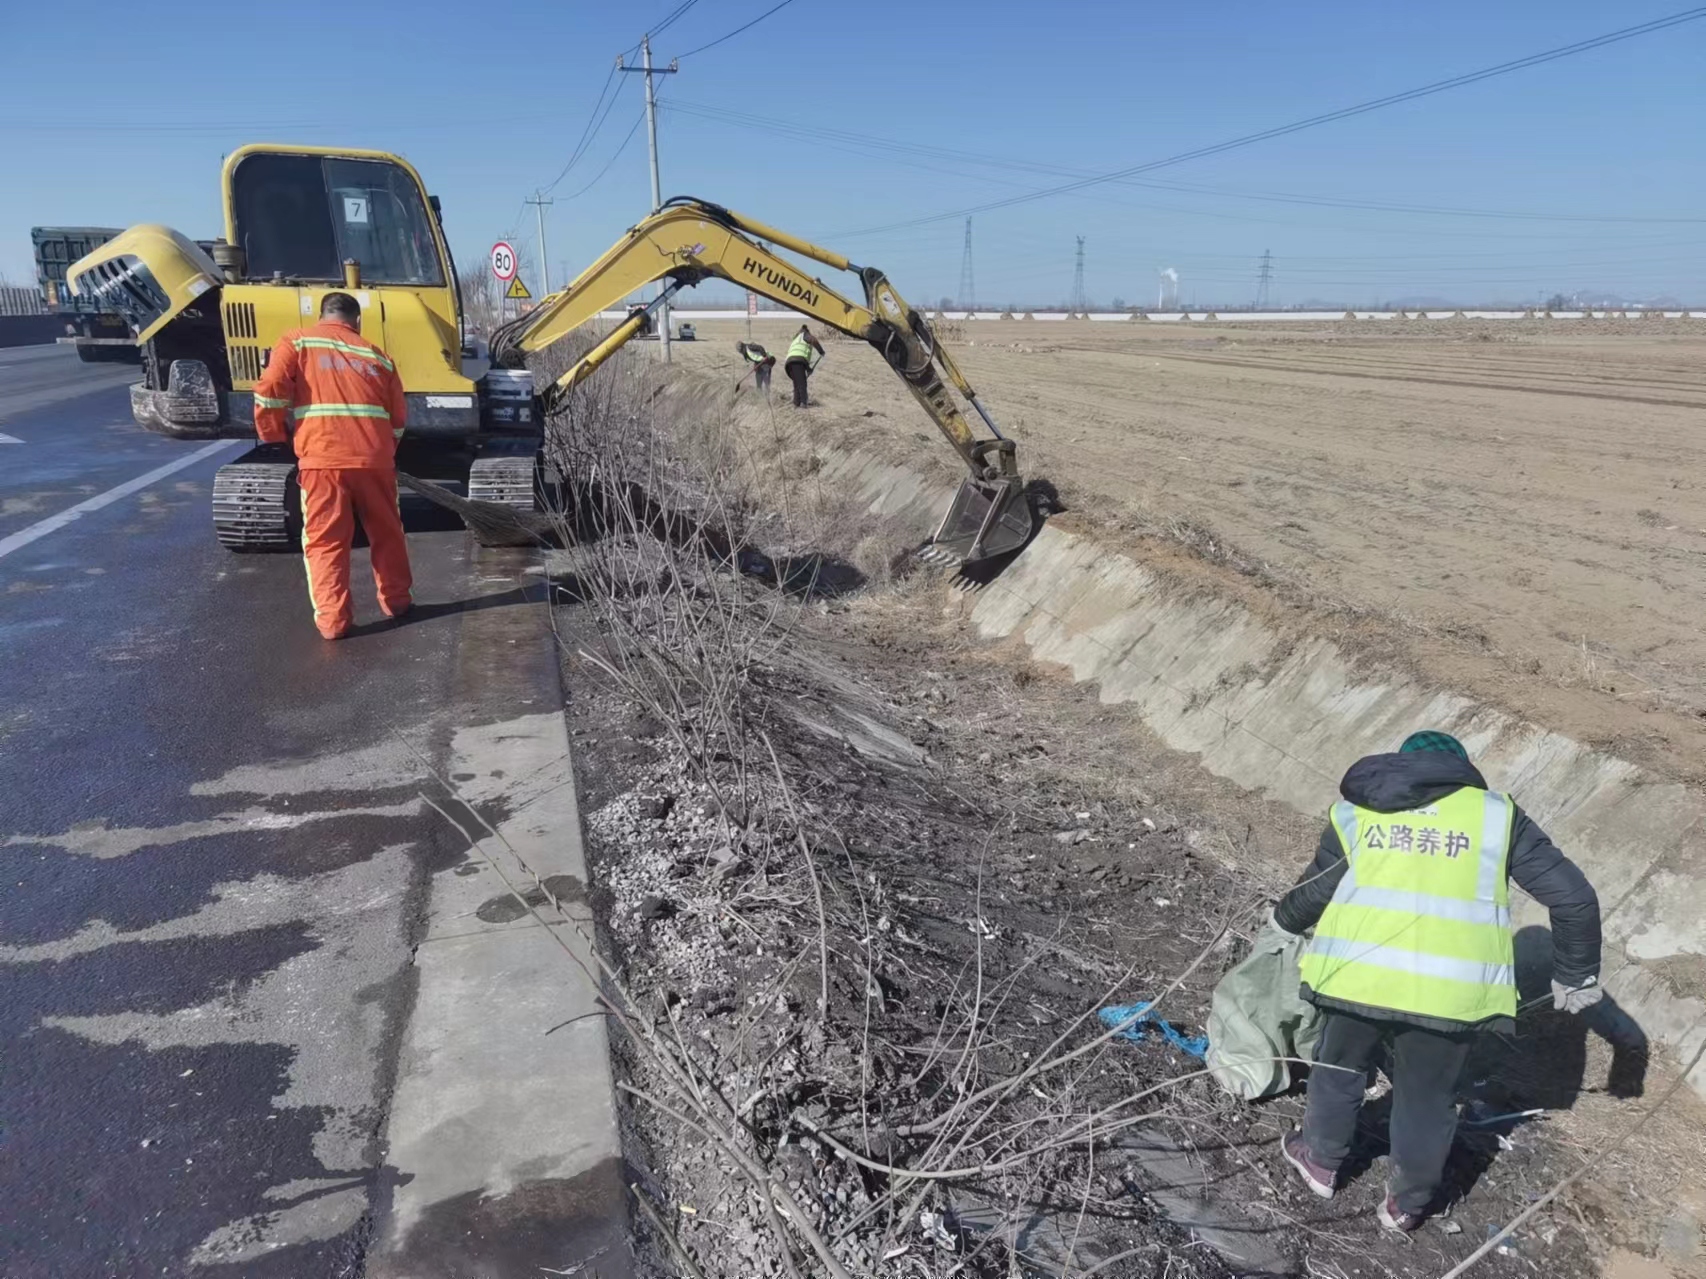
0, 0, 1706, 305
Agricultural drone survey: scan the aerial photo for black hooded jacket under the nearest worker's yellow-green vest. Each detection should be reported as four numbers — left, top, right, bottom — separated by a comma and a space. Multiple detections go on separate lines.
1274, 750, 1600, 1028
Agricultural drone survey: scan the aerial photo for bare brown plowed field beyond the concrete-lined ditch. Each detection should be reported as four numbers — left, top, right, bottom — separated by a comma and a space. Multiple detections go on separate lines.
676, 319, 1706, 774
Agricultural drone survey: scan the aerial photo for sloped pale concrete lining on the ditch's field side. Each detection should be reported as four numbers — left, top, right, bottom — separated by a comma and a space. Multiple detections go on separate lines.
819, 450, 1706, 1097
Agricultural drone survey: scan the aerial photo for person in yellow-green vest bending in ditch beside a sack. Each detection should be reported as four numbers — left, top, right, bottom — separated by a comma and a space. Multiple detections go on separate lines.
1274, 732, 1600, 1233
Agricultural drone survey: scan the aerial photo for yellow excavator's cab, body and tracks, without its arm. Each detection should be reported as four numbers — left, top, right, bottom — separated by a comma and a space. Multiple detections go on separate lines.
67, 145, 541, 551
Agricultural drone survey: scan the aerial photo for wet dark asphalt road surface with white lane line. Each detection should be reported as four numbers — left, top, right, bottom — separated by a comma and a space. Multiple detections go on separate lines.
0, 348, 614, 1279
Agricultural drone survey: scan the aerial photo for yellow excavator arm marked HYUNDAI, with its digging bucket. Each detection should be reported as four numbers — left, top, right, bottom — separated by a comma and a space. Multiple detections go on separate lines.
491, 198, 1032, 561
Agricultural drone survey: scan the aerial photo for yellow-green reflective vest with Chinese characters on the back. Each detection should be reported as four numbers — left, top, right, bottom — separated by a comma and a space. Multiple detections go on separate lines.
1302, 786, 1517, 1025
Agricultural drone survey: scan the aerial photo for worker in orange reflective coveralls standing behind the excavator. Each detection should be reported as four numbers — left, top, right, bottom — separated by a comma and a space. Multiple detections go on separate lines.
254, 293, 413, 640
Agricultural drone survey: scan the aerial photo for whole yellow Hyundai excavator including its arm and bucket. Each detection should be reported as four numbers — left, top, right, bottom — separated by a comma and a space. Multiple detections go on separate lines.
67, 145, 1032, 561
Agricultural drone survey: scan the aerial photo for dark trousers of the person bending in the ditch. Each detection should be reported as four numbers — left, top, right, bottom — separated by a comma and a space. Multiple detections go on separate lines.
1303, 1013, 1474, 1212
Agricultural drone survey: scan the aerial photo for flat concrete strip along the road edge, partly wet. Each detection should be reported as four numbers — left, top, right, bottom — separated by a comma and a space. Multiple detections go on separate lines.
367, 569, 633, 1279
